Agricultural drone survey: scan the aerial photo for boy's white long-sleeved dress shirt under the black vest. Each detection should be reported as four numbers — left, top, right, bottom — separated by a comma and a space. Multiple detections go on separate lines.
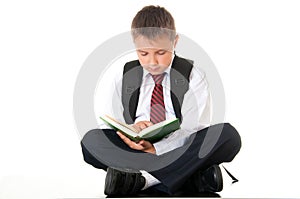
97, 55, 211, 155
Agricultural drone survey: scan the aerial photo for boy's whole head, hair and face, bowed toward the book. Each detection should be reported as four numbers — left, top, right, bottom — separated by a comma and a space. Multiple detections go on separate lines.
131, 6, 178, 75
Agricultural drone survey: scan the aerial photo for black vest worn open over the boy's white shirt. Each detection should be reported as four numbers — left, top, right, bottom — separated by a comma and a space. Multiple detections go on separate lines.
122, 55, 193, 124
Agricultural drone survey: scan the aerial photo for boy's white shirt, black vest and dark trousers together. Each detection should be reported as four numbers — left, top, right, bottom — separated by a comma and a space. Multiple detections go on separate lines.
81, 55, 241, 194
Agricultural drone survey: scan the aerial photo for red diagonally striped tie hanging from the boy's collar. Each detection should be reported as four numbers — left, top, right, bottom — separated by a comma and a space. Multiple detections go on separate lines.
150, 73, 166, 124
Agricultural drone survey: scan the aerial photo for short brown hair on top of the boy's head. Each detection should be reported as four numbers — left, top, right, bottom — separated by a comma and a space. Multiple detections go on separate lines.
131, 5, 176, 40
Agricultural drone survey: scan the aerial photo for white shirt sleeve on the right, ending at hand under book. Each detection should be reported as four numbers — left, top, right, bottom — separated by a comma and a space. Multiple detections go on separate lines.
153, 66, 211, 155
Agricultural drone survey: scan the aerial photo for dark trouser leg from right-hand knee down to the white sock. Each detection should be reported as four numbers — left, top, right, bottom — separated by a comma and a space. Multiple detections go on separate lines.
150, 123, 241, 193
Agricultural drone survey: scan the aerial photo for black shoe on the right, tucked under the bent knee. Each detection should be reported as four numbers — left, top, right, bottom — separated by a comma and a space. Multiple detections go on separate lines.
183, 165, 223, 193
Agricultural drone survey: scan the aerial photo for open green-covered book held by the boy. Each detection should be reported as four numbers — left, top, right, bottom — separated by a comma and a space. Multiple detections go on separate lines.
100, 115, 180, 143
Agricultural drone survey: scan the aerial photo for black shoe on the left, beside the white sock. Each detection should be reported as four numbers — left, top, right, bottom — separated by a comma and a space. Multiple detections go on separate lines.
104, 167, 146, 196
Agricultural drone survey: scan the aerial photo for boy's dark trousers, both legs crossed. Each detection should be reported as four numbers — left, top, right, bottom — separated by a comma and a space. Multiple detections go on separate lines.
81, 123, 241, 194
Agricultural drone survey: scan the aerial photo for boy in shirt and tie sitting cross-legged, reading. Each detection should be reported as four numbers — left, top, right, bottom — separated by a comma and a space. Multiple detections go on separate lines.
81, 6, 241, 195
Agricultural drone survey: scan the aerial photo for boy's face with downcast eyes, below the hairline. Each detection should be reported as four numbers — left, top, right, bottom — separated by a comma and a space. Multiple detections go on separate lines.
134, 36, 178, 75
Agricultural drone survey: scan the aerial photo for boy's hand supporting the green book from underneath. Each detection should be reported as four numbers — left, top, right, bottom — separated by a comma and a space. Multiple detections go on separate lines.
117, 131, 156, 154
